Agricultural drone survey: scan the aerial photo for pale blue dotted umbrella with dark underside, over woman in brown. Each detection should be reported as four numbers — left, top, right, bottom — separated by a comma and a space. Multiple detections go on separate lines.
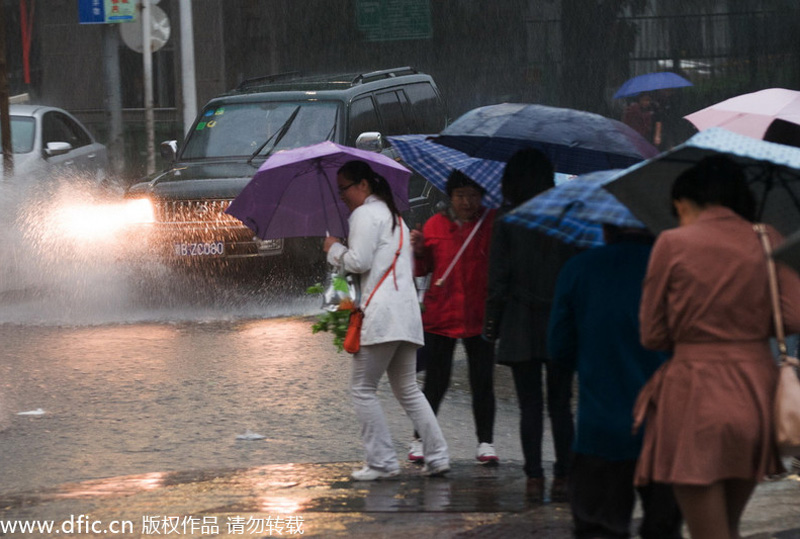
605, 127, 800, 236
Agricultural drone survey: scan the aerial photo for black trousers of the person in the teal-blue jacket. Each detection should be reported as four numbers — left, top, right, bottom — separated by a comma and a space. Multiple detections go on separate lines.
569, 453, 683, 539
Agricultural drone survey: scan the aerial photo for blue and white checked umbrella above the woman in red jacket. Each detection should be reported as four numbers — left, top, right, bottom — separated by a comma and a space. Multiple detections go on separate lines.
387, 135, 506, 208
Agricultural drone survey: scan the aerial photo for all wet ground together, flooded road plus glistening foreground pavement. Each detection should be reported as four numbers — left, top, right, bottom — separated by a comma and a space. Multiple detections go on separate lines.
0, 289, 800, 539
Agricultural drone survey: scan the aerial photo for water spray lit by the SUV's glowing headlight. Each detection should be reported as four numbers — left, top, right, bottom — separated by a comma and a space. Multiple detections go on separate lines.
0, 177, 318, 325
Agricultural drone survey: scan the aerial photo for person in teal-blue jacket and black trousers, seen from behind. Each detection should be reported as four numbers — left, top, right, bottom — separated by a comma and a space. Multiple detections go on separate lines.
547, 225, 682, 539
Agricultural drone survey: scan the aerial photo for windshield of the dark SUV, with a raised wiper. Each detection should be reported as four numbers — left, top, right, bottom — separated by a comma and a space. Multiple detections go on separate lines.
181, 101, 339, 159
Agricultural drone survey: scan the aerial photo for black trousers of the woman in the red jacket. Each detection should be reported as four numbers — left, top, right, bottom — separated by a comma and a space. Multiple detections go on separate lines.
414, 332, 495, 443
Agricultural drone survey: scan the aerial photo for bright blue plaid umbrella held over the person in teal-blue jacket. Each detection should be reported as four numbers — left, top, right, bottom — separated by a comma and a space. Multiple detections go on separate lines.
502, 169, 645, 247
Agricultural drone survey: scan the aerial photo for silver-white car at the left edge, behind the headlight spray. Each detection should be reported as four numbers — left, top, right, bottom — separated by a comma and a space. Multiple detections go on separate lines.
0, 104, 108, 185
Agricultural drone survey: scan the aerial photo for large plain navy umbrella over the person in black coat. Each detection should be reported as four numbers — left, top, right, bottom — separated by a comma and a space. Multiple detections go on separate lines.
431, 103, 658, 174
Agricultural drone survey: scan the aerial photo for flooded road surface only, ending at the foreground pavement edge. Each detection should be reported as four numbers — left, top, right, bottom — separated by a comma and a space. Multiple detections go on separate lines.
0, 284, 521, 492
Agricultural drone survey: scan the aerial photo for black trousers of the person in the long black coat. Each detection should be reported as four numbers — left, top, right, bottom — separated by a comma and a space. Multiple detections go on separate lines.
511, 359, 575, 477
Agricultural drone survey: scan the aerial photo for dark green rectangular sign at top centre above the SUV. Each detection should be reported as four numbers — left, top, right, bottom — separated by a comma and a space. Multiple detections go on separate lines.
356, 0, 433, 41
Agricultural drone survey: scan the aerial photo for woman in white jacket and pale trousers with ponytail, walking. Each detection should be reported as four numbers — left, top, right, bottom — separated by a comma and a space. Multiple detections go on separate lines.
324, 161, 450, 481
